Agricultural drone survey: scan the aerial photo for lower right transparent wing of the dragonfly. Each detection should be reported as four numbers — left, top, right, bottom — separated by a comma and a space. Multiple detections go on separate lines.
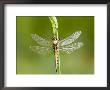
59, 42, 83, 54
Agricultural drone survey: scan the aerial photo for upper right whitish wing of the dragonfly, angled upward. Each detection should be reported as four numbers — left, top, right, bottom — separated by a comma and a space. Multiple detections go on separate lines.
59, 31, 81, 46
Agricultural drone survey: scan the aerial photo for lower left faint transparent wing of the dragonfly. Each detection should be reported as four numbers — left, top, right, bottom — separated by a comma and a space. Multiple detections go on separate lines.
29, 46, 52, 54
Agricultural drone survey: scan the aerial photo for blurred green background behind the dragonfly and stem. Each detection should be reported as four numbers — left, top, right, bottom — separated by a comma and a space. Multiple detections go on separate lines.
16, 16, 94, 75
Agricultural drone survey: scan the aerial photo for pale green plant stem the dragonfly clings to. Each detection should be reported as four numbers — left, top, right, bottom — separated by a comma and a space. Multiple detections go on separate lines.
49, 16, 61, 74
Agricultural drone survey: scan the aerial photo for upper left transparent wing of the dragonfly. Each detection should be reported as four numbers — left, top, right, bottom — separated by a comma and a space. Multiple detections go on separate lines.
31, 34, 51, 46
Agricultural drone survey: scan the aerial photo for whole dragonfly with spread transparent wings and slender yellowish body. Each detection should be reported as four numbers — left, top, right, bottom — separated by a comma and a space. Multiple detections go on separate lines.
29, 31, 83, 72
